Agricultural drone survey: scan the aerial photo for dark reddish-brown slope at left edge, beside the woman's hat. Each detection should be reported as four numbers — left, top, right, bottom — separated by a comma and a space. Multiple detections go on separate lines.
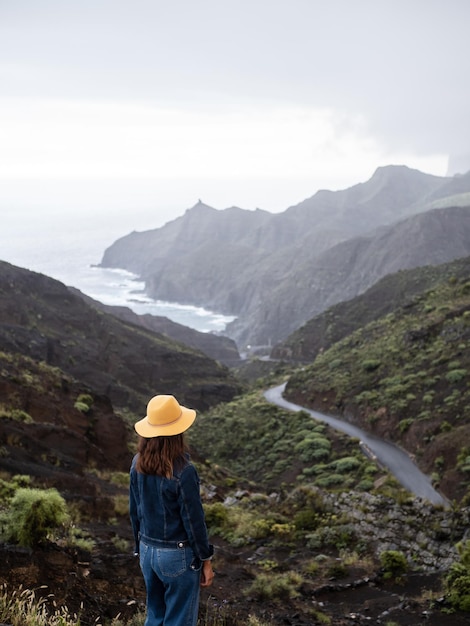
0, 353, 130, 476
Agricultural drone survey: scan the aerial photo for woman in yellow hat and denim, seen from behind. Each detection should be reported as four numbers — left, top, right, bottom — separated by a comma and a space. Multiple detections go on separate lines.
129, 395, 214, 626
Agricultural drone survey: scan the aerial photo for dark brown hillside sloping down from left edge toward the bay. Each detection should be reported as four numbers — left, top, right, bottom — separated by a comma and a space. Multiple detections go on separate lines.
0, 262, 240, 411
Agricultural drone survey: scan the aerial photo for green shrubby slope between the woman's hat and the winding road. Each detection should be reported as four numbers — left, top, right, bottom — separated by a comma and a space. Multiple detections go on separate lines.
188, 392, 377, 489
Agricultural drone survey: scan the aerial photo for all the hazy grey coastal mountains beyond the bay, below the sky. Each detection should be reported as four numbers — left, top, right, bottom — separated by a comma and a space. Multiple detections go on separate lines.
101, 166, 470, 349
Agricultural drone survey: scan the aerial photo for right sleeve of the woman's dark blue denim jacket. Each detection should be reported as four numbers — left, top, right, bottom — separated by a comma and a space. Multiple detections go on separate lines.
179, 463, 214, 561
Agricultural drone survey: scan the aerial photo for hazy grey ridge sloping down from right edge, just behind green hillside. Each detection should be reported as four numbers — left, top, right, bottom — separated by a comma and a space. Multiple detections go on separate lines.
228, 207, 470, 345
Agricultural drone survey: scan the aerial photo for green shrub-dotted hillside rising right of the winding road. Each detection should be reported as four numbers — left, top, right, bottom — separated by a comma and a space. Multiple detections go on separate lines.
286, 275, 470, 499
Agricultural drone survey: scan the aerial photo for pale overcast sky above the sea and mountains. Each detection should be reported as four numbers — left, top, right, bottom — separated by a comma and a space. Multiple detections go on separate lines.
0, 0, 470, 225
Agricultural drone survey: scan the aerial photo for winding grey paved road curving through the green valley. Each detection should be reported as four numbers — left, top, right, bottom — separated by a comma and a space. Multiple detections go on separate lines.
264, 383, 448, 505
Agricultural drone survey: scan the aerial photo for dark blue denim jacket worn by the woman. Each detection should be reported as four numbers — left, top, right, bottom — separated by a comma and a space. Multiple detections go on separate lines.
129, 455, 214, 561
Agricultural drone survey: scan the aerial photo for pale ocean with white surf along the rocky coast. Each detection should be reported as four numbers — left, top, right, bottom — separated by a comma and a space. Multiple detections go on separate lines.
0, 209, 234, 332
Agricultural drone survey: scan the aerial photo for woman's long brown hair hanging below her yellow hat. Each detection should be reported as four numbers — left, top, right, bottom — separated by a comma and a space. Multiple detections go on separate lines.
136, 433, 188, 478
